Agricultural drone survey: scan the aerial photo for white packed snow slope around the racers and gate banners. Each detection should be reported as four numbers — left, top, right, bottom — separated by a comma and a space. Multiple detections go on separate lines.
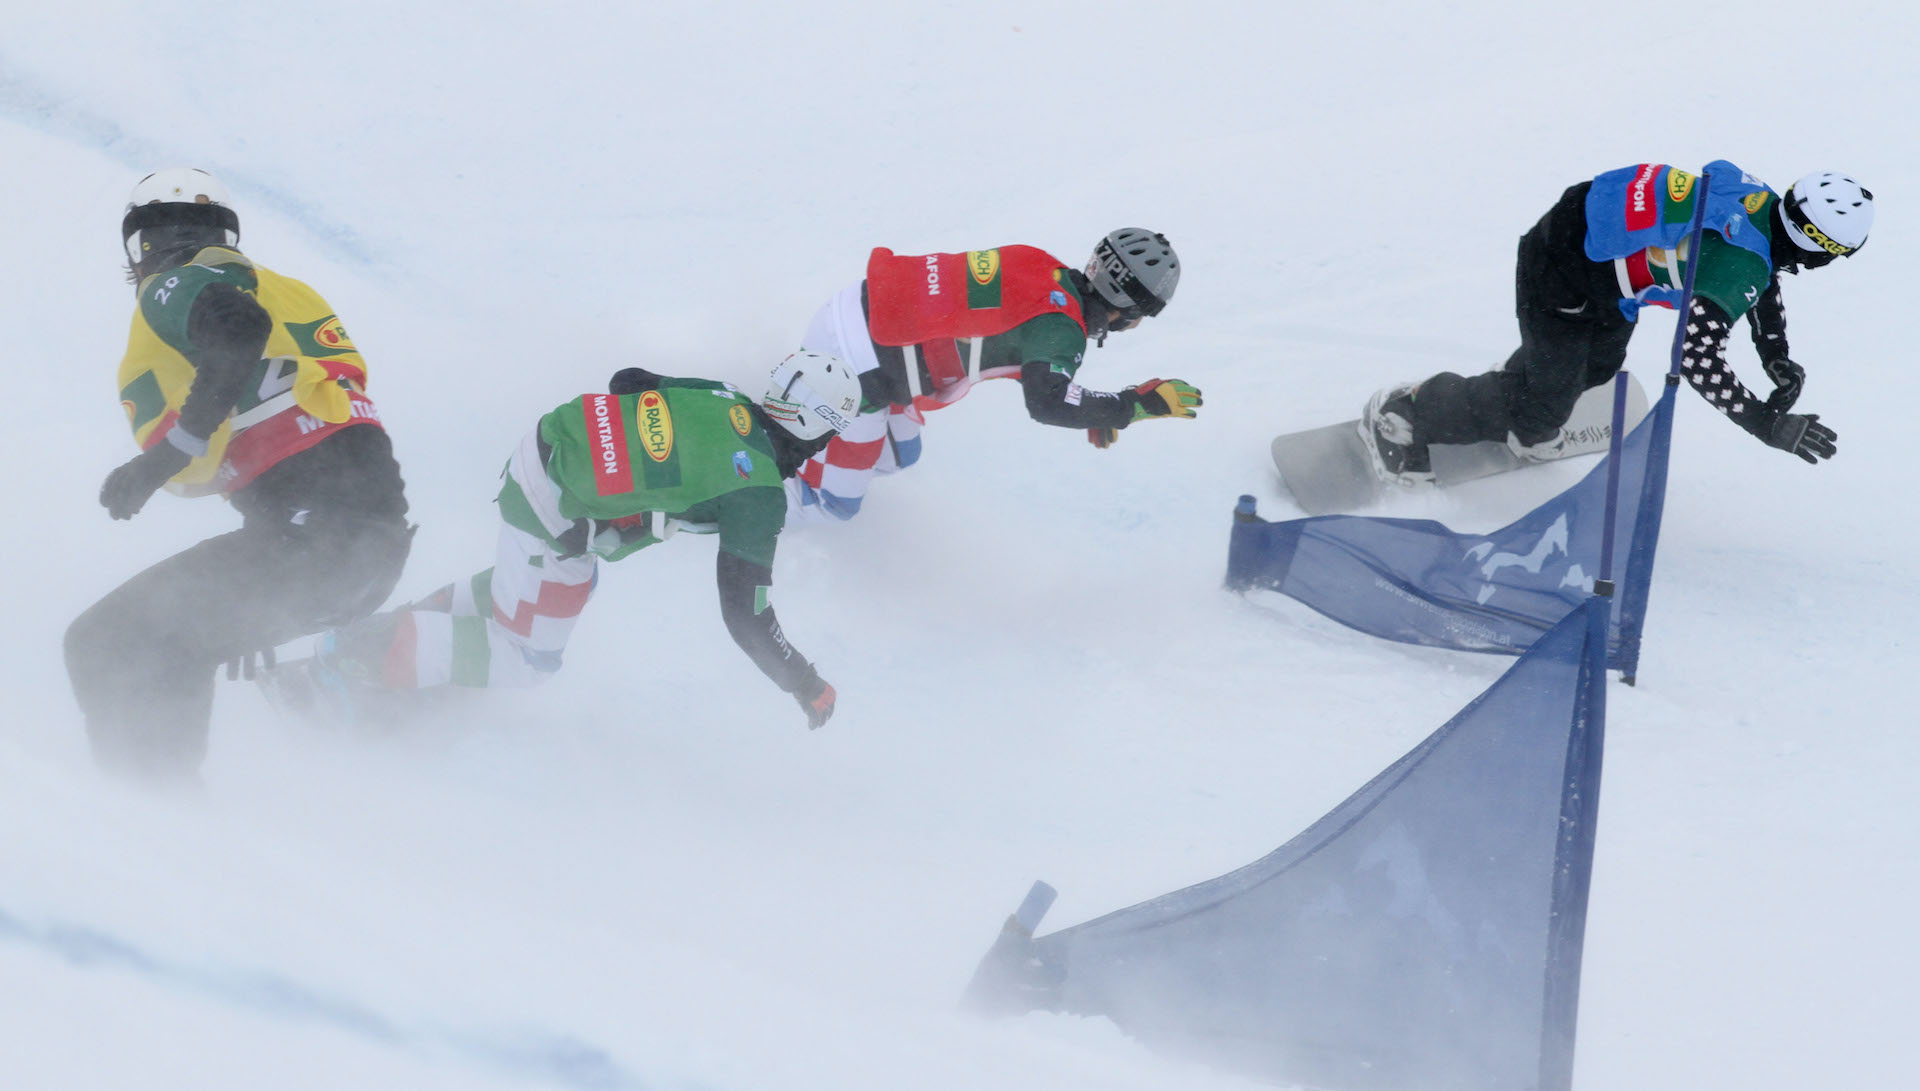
0, 0, 1920, 1091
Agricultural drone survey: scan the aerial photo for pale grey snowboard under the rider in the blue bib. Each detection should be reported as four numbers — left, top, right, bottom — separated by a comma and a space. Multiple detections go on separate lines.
1273, 375, 1647, 515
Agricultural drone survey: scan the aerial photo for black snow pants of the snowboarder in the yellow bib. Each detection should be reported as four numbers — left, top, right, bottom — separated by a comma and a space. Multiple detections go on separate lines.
65, 509, 413, 780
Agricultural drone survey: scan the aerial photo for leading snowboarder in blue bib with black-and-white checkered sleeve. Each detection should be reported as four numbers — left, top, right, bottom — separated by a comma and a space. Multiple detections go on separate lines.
1359, 159, 1874, 486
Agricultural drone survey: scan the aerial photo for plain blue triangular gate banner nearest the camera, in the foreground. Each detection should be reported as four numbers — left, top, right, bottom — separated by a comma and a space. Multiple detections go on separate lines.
968, 595, 1607, 1091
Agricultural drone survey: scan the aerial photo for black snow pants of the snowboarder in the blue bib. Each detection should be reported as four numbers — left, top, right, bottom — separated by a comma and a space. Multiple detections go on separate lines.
1413, 182, 1634, 444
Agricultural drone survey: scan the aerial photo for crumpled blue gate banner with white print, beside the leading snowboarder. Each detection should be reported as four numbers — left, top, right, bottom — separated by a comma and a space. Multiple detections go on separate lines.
1227, 382, 1676, 676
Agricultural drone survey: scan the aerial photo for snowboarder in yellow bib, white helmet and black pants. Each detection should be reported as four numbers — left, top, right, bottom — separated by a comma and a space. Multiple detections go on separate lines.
65, 167, 411, 778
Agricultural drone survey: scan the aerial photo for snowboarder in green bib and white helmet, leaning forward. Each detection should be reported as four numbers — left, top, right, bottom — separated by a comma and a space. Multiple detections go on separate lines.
265, 352, 860, 728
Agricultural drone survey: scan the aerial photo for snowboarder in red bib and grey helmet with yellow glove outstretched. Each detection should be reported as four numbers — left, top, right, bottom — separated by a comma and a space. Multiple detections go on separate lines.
787, 227, 1200, 522
